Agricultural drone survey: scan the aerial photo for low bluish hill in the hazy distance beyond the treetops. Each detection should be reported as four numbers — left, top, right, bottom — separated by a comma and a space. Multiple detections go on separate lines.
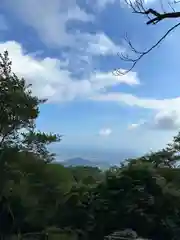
61, 157, 110, 169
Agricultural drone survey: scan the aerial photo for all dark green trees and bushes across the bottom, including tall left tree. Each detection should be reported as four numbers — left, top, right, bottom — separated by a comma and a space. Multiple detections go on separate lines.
0, 52, 180, 240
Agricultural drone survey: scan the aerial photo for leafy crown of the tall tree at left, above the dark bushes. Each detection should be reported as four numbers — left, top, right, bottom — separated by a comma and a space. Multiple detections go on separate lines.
0, 51, 60, 158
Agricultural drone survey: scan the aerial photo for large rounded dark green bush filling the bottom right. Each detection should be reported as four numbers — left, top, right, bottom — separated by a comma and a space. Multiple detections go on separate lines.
91, 158, 180, 240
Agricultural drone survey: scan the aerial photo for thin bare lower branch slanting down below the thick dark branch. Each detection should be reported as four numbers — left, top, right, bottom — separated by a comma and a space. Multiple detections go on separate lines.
113, 22, 180, 76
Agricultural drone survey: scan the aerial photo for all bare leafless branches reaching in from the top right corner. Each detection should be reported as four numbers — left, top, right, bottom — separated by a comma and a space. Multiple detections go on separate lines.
114, 0, 180, 75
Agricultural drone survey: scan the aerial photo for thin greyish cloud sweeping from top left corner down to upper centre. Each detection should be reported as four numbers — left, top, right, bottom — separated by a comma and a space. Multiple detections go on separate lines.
3, 0, 125, 82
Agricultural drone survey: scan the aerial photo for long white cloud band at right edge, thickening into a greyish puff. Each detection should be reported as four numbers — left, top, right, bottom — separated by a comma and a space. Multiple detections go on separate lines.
93, 93, 180, 130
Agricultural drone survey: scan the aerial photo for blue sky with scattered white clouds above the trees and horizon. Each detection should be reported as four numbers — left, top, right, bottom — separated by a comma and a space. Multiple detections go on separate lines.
0, 0, 180, 161
